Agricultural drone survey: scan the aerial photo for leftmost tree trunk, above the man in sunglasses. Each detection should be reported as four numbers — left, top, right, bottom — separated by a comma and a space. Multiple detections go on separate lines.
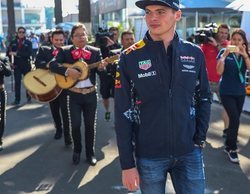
7, 0, 16, 41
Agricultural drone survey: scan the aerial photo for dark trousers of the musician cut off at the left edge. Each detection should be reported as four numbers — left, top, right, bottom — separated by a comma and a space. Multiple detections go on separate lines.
0, 89, 7, 144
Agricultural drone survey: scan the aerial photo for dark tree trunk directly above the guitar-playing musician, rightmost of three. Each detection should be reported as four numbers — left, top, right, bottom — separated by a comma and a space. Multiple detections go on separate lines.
79, 0, 91, 23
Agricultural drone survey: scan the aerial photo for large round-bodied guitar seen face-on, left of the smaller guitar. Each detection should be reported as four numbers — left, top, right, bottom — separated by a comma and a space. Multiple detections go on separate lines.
23, 69, 62, 102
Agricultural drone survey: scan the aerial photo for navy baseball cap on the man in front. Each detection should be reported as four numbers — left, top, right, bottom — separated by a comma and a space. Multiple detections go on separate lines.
135, 0, 180, 11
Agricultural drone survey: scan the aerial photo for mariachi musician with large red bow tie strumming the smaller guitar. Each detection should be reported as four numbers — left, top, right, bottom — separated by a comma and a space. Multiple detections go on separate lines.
50, 23, 107, 166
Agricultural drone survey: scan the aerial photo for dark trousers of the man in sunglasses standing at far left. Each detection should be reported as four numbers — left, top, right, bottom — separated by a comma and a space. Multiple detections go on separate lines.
14, 66, 31, 102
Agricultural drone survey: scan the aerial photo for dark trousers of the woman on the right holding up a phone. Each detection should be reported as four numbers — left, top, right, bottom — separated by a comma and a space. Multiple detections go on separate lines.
221, 95, 245, 150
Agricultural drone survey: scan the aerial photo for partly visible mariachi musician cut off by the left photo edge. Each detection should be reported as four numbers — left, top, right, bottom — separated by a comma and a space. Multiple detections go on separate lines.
0, 57, 11, 151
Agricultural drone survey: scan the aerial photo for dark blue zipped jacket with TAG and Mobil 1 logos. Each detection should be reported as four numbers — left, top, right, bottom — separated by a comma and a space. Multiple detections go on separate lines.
115, 33, 211, 169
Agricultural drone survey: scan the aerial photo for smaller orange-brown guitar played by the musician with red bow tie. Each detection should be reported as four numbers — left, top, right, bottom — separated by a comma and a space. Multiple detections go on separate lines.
55, 55, 119, 89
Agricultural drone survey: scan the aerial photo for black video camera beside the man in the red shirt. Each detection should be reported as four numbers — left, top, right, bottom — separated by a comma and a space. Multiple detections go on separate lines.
194, 23, 217, 44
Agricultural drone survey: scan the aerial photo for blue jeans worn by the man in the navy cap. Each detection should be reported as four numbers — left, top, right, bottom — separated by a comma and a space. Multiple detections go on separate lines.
137, 147, 205, 194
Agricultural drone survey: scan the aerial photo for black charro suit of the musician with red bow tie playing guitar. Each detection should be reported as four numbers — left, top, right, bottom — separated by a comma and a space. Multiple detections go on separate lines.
50, 45, 101, 158
